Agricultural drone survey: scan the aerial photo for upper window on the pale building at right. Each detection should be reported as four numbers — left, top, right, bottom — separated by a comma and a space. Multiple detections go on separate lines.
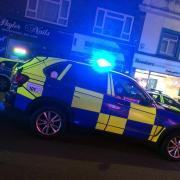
159, 32, 179, 57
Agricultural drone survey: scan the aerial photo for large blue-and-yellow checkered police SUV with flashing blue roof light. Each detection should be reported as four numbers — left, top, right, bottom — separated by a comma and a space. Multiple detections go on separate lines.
6, 57, 180, 160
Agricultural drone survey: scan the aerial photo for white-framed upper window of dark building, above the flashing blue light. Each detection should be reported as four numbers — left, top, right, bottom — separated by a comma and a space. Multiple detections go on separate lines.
93, 8, 134, 41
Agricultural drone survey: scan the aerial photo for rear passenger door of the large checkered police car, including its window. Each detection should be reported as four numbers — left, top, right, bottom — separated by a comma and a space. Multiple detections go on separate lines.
71, 64, 108, 130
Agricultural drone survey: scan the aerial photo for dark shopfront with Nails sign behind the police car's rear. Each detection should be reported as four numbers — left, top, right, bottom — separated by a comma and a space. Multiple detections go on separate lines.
0, 17, 73, 59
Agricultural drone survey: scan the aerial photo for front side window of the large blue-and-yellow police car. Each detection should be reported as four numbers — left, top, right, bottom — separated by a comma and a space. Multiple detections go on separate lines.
113, 74, 147, 105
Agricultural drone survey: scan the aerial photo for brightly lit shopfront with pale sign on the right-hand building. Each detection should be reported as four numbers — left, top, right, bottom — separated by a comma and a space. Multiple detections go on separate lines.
133, 54, 180, 99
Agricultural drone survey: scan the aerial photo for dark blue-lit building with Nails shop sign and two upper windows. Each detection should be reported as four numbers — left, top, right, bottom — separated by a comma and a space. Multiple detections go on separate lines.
0, 0, 145, 73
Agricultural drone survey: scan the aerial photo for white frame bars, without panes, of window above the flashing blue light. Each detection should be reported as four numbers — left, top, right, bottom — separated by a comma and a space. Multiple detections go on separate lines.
93, 7, 134, 41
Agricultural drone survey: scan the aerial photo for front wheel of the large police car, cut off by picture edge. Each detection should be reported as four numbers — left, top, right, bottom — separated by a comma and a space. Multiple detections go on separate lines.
160, 132, 180, 161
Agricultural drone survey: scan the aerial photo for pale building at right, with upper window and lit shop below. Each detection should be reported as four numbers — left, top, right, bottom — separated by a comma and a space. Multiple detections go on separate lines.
133, 0, 180, 99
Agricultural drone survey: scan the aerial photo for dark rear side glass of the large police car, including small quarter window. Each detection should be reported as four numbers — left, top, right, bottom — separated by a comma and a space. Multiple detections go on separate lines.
44, 61, 107, 94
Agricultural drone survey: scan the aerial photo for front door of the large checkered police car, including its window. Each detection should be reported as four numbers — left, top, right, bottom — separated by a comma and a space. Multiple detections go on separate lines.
108, 73, 156, 139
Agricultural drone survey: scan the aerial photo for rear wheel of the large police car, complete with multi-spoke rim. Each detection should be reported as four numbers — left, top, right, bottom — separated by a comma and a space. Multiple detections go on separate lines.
31, 106, 66, 138
